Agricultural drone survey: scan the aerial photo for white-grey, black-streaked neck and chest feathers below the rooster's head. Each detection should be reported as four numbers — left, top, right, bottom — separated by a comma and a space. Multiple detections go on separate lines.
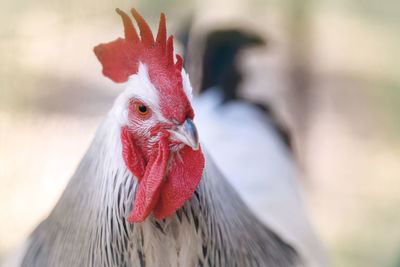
17, 113, 300, 267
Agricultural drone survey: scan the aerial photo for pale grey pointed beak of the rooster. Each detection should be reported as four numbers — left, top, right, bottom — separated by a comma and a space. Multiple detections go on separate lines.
170, 118, 199, 150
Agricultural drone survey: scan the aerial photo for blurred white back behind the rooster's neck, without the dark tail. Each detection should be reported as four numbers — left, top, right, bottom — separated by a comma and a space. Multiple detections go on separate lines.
194, 90, 325, 266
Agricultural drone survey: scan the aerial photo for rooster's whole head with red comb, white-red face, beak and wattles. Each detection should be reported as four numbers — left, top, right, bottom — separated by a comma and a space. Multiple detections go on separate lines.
94, 9, 204, 222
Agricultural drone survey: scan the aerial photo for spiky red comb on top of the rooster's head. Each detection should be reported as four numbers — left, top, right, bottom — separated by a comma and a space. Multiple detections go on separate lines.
94, 8, 181, 82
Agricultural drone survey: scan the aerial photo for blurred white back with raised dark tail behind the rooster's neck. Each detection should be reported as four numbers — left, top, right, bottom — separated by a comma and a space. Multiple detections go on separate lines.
194, 29, 325, 266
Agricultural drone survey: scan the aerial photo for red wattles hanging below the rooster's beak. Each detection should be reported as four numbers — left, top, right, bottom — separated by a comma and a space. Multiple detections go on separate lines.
121, 127, 204, 222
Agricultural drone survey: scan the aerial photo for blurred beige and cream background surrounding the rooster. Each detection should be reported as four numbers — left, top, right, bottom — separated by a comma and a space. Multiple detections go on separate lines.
0, 0, 400, 267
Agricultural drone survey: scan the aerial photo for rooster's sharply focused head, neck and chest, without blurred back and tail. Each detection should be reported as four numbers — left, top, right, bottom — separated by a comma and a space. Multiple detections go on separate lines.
4, 9, 310, 267
